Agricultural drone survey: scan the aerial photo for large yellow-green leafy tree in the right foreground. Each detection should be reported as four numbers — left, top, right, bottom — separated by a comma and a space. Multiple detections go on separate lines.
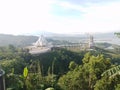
59, 53, 111, 90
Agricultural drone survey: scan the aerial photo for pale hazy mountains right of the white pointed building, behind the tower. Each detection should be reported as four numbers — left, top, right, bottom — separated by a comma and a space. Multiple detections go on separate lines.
44, 32, 120, 45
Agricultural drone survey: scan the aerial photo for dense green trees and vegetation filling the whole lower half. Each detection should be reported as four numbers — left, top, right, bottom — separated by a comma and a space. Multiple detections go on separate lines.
0, 45, 120, 90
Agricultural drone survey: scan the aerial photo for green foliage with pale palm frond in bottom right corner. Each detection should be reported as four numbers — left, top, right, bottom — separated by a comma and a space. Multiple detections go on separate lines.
95, 66, 120, 90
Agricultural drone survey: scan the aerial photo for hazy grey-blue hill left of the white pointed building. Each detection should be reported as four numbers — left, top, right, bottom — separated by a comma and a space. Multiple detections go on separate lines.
0, 34, 38, 47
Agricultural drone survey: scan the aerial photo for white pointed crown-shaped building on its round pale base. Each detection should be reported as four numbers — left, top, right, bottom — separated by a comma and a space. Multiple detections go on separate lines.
34, 35, 48, 47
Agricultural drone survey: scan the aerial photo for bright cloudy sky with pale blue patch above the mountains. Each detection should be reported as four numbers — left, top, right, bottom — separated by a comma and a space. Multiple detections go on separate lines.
0, 0, 120, 35
